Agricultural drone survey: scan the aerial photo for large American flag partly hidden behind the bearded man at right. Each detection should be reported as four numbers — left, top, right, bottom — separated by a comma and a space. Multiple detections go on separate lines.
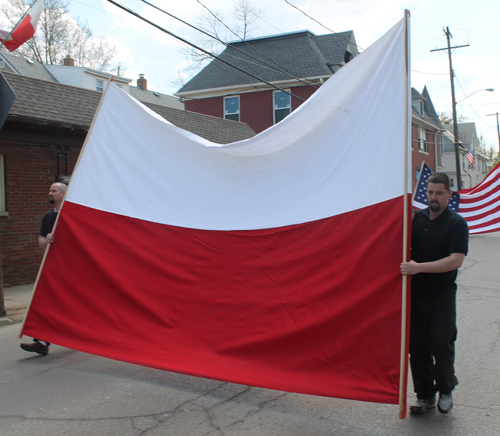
413, 163, 500, 234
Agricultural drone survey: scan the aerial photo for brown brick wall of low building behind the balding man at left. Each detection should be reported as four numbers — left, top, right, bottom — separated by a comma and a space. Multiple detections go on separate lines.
0, 141, 80, 287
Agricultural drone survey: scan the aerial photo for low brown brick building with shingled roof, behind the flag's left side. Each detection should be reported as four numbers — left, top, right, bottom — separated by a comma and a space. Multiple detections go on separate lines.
0, 72, 255, 286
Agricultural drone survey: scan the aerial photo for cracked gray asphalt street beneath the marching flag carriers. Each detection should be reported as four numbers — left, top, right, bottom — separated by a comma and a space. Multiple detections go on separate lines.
0, 233, 500, 436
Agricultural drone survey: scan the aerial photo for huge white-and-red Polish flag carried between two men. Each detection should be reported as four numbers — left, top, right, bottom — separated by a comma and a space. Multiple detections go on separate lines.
22, 18, 411, 404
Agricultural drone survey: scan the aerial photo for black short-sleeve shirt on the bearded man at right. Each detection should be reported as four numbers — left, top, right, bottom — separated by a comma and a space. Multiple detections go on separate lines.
411, 208, 469, 296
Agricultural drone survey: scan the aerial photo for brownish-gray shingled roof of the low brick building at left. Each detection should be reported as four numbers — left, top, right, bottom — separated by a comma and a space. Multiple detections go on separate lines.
2, 72, 255, 144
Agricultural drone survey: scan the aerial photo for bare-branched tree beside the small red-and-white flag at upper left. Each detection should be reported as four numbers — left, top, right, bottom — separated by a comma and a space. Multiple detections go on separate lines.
0, 0, 116, 71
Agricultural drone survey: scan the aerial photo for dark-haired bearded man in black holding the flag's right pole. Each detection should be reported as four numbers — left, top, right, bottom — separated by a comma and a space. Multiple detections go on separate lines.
401, 173, 469, 413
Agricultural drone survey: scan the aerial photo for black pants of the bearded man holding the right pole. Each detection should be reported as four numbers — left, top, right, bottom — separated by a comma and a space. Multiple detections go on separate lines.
410, 294, 458, 400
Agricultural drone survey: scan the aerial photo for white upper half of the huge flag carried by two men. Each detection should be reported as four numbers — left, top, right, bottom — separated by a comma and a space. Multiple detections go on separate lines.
66, 18, 411, 230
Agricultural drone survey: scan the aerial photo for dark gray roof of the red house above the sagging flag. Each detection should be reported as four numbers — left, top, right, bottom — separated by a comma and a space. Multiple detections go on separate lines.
177, 31, 357, 93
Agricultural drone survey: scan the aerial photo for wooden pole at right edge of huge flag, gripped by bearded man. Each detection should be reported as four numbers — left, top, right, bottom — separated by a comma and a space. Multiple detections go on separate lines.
399, 9, 411, 419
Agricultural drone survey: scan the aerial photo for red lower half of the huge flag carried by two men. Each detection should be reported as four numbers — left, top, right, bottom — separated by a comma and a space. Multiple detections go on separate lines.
23, 198, 403, 404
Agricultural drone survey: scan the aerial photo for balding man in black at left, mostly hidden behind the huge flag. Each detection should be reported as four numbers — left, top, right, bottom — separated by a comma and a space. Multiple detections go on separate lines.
21, 183, 67, 355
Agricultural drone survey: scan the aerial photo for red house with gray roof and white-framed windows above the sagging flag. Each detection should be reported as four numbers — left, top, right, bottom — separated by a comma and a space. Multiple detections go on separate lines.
175, 30, 358, 133
